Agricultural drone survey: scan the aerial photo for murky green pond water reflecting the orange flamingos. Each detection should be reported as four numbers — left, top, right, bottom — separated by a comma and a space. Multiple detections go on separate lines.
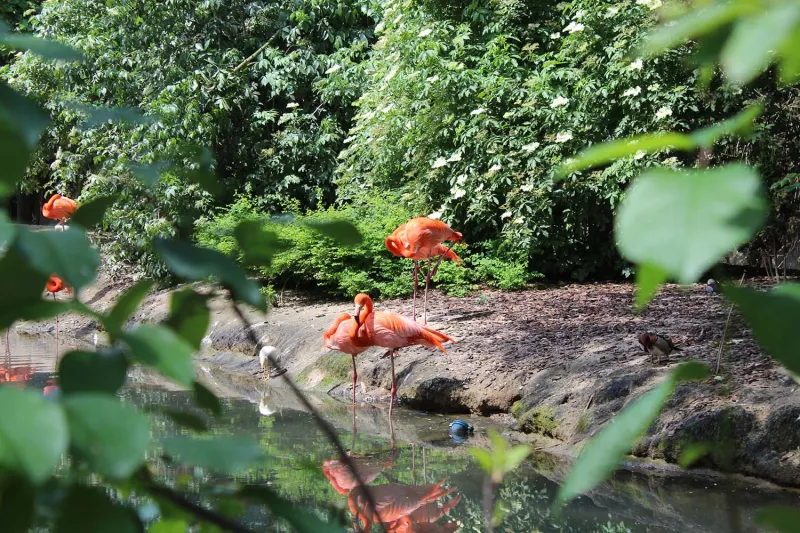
0, 334, 799, 533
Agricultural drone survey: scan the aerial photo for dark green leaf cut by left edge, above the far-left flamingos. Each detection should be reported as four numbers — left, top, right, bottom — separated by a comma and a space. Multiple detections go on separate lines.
0, 81, 50, 192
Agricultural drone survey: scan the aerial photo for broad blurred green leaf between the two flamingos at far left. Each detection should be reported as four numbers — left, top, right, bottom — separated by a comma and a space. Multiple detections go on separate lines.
17, 228, 100, 290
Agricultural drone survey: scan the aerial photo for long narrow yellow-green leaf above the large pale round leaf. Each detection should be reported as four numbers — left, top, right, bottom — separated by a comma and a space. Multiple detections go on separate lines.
556, 104, 764, 179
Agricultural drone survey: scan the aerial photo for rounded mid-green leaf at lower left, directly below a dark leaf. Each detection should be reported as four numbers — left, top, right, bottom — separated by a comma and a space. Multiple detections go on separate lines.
64, 392, 150, 480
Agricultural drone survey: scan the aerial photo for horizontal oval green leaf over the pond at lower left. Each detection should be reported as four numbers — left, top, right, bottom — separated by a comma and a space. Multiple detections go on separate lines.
162, 437, 264, 473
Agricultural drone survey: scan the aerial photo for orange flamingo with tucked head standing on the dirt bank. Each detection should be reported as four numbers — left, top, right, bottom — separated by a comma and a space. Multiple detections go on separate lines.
385, 217, 463, 325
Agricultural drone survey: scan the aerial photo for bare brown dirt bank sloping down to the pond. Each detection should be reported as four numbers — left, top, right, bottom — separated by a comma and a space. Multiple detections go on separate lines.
17, 277, 800, 486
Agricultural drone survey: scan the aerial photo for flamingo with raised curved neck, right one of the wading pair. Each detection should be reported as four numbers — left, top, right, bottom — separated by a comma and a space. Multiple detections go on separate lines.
350, 293, 456, 414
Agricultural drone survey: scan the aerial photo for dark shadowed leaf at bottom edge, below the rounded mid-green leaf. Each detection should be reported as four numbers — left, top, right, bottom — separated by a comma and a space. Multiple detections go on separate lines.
53, 485, 143, 533
